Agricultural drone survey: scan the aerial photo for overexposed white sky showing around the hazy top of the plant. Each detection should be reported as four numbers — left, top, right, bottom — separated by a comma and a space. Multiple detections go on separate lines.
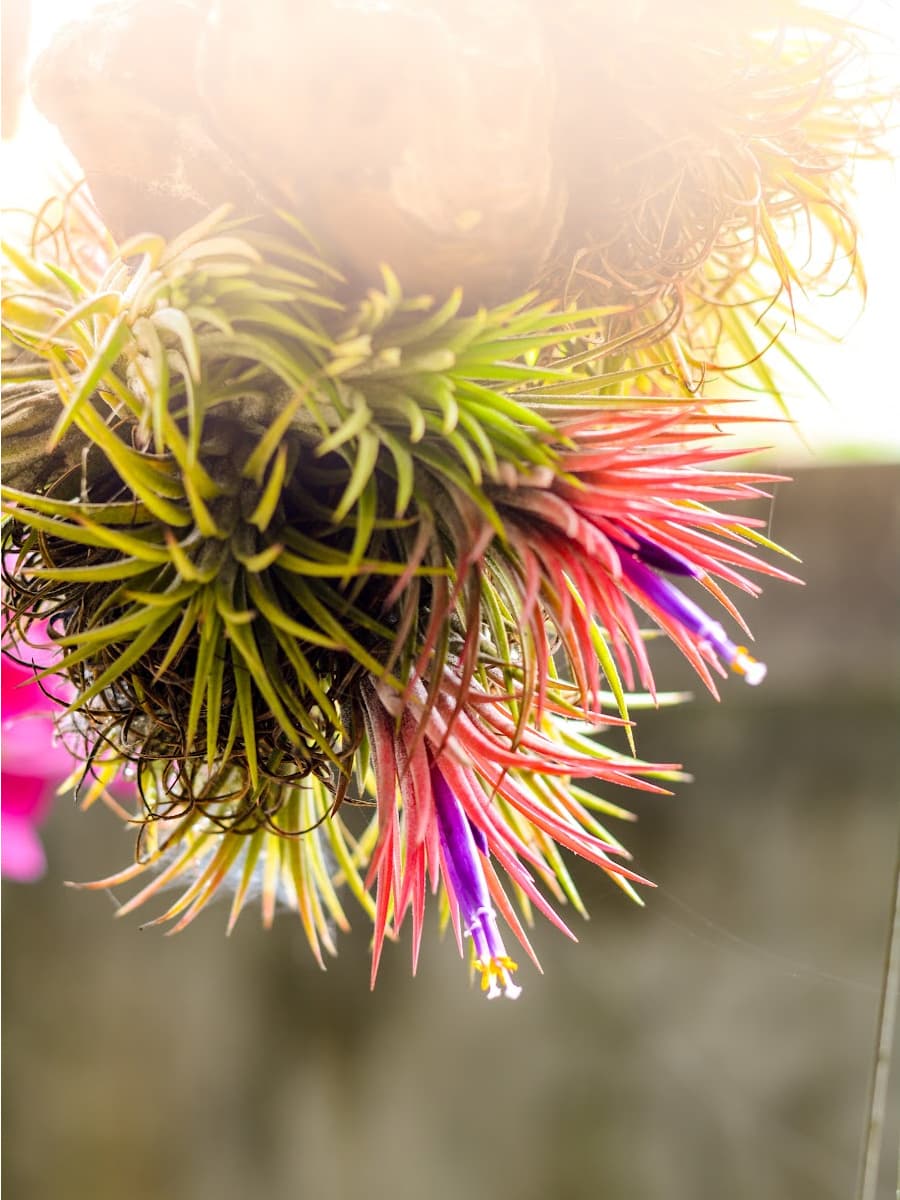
0, 0, 900, 464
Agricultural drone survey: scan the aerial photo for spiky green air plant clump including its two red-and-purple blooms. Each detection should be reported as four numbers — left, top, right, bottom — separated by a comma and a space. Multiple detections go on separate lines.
4, 214, 796, 995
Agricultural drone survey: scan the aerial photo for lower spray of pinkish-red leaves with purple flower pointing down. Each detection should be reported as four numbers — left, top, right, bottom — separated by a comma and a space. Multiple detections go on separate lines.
364, 667, 657, 998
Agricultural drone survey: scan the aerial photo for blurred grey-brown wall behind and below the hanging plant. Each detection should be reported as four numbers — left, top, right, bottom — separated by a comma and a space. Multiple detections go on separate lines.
2, 467, 900, 1200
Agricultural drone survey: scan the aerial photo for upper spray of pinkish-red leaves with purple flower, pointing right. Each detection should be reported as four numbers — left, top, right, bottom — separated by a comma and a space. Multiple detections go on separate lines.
498, 417, 796, 715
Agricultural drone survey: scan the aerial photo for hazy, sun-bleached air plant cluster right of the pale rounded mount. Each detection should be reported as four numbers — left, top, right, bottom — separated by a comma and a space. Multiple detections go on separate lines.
541, 0, 892, 395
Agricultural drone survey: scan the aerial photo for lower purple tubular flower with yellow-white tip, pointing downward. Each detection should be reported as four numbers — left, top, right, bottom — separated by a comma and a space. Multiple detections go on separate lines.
431, 763, 522, 1000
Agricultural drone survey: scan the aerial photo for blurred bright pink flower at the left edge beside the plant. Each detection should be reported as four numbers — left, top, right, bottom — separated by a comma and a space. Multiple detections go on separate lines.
0, 646, 73, 883
